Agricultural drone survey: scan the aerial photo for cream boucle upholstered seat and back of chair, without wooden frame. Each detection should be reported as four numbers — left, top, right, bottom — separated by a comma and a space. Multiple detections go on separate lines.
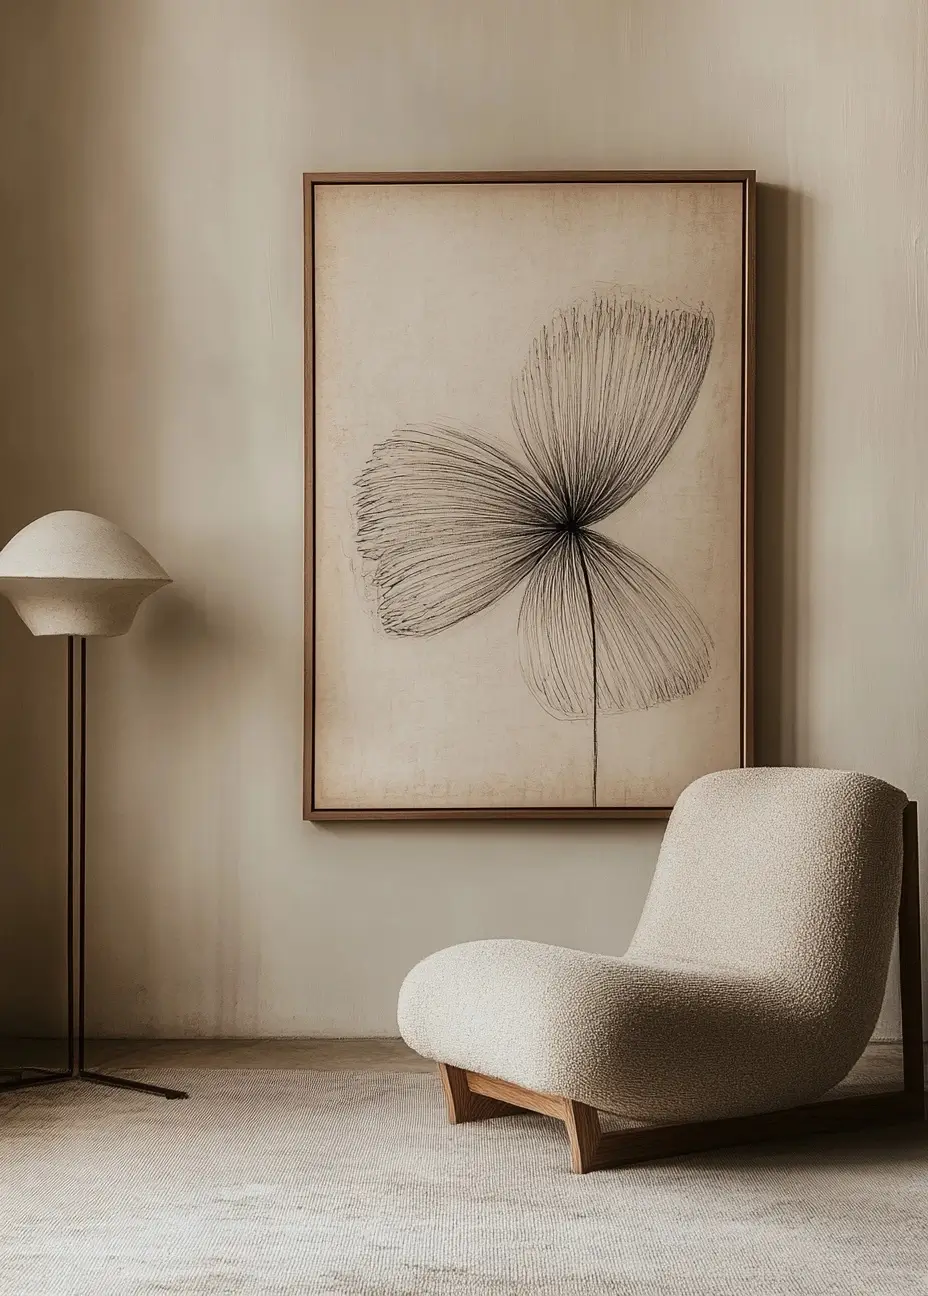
398, 769, 906, 1121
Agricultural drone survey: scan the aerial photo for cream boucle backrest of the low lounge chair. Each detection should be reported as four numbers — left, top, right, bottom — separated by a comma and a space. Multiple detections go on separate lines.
629, 769, 907, 1024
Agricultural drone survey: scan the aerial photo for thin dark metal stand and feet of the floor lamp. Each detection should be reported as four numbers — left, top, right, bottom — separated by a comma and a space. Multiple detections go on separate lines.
0, 635, 188, 1098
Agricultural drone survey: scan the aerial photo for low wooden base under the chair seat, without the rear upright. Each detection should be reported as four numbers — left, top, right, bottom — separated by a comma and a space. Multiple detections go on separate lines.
438, 1063, 925, 1174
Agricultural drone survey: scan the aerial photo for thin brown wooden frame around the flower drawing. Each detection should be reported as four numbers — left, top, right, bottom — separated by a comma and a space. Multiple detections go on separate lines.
303, 170, 757, 823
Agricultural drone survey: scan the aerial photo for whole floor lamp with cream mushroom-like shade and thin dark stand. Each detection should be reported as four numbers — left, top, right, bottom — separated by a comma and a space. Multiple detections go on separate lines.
0, 511, 187, 1098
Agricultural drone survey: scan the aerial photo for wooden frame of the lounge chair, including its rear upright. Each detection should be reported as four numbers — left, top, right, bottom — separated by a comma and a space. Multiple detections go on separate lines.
438, 801, 925, 1174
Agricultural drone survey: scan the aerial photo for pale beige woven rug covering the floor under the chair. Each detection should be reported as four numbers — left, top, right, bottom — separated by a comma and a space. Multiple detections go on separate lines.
0, 1070, 928, 1296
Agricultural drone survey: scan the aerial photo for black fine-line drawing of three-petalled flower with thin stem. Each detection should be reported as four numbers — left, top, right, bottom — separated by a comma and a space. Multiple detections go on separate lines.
356, 295, 714, 805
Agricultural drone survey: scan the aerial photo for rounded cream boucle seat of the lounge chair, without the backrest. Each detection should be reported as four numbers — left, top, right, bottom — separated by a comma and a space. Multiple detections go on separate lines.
398, 940, 866, 1121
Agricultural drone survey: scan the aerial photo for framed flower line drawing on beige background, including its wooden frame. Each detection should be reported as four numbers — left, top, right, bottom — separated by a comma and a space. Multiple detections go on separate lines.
305, 171, 754, 819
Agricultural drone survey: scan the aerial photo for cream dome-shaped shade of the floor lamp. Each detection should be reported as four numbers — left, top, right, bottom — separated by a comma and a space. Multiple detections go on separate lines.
0, 509, 171, 635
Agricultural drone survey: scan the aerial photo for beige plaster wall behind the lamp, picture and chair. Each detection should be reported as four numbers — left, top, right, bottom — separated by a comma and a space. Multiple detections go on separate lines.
0, 0, 928, 1036
